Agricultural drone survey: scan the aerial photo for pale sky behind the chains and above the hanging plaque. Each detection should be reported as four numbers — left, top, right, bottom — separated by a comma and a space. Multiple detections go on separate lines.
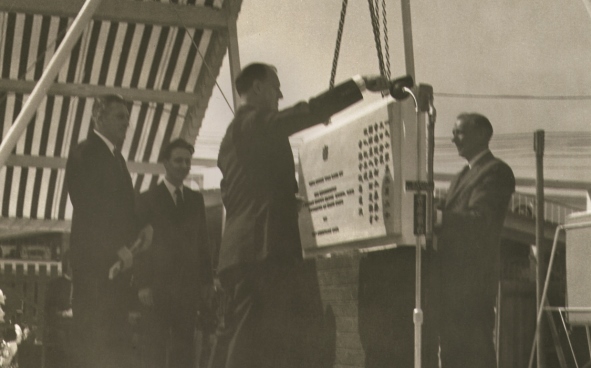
197, 0, 591, 187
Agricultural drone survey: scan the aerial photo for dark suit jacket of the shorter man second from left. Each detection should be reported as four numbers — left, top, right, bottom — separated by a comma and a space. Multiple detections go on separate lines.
134, 182, 213, 303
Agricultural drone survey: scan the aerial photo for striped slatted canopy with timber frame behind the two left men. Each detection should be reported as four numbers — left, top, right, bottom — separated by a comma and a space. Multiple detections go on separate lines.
0, 0, 242, 240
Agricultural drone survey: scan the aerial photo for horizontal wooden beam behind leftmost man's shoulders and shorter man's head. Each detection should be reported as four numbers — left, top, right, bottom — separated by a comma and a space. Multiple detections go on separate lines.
6, 155, 217, 170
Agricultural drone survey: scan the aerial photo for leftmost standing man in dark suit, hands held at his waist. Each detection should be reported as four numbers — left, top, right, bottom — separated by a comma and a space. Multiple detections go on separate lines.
66, 95, 150, 368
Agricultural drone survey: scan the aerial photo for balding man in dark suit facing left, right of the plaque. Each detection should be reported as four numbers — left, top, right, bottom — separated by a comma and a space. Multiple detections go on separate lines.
437, 113, 515, 368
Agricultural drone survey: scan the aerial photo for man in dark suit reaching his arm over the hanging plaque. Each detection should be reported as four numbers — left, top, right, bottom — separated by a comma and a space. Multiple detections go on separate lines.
210, 63, 388, 368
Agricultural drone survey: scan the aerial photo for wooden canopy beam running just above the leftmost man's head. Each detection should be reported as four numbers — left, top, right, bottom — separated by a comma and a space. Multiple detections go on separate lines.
0, 79, 197, 105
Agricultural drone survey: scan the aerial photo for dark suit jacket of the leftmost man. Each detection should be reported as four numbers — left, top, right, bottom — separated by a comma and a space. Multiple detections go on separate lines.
66, 132, 137, 284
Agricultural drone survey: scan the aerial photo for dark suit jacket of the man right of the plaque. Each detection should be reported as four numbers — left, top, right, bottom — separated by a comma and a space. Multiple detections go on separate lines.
437, 152, 515, 297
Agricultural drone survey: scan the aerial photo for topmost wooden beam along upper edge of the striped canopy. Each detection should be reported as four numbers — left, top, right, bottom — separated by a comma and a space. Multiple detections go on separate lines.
0, 0, 228, 29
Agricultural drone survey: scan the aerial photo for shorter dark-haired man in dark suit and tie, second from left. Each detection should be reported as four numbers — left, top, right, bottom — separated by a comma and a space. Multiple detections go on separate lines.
135, 139, 213, 368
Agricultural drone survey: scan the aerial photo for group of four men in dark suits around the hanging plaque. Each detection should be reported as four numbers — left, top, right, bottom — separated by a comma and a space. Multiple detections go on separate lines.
59, 63, 515, 368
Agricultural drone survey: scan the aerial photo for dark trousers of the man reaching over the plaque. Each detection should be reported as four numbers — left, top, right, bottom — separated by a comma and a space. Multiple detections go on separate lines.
209, 261, 327, 368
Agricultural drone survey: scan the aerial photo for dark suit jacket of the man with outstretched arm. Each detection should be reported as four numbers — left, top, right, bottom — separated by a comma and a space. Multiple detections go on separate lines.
218, 80, 363, 272
